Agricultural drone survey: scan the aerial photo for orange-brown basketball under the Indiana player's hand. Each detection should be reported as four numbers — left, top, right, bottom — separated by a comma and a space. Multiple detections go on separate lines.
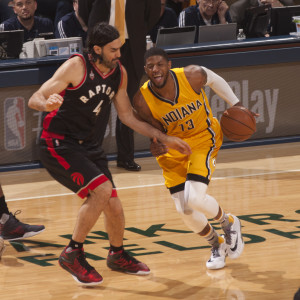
220, 106, 256, 142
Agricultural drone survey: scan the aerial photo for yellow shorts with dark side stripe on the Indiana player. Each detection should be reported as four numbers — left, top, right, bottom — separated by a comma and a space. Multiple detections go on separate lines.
157, 118, 223, 193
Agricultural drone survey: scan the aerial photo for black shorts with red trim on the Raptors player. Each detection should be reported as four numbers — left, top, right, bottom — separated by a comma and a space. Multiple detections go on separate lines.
39, 137, 117, 198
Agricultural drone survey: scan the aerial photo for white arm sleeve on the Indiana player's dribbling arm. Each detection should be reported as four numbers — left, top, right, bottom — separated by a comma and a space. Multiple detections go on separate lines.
201, 67, 239, 106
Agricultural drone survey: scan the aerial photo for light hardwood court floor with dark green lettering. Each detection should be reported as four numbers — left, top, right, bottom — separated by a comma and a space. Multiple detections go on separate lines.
0, 143, 300, 300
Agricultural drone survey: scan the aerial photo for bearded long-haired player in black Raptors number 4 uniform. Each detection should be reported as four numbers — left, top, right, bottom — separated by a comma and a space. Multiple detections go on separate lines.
29, 23, 191, 285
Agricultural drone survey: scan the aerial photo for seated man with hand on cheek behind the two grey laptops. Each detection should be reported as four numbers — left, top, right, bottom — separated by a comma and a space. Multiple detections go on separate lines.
178, 0, 232, 42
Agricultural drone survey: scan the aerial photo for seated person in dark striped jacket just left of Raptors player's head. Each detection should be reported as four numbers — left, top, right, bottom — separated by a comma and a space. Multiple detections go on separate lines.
55, 0, 87, 47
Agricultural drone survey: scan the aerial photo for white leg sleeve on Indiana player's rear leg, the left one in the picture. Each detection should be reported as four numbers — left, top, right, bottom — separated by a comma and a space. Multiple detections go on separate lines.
171, 191, 208, 233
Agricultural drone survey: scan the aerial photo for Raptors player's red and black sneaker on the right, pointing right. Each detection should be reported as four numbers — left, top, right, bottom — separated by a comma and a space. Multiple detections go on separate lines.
106, 250, 150, 275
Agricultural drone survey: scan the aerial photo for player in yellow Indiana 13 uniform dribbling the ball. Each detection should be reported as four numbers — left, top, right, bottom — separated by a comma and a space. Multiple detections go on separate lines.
134, 48, 258, 269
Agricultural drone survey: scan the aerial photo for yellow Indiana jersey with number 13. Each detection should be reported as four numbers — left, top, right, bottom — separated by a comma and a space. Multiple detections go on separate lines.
140, 68, 213, 139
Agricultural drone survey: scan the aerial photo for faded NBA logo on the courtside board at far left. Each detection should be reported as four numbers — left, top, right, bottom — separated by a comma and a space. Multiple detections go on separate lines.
4, 97, 25, 150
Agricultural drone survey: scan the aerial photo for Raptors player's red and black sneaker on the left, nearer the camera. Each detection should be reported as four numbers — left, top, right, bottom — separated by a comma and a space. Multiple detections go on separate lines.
58, 247, 103, 285
